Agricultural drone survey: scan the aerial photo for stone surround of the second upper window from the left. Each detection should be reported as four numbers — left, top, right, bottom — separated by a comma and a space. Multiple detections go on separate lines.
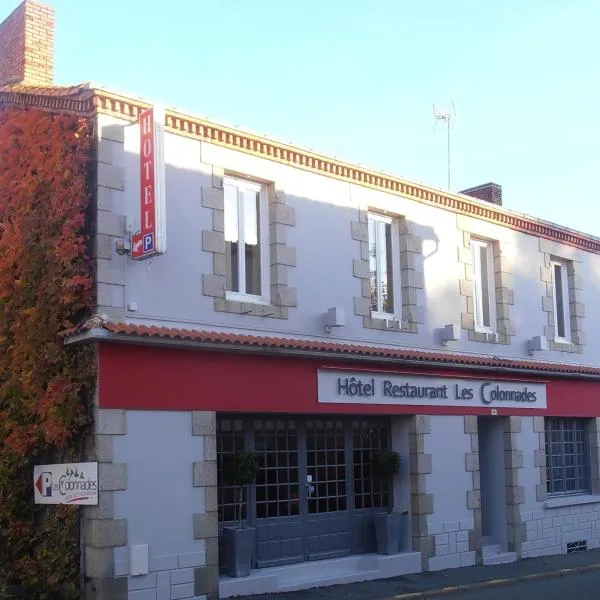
351, 208, 425, 333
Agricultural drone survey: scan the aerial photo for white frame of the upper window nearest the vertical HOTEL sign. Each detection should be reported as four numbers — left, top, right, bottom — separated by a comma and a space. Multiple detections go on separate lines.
223, 177, 271, 304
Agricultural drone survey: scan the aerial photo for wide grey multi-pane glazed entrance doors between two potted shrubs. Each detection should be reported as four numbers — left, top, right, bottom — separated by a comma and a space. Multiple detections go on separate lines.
217, 416, 390, 568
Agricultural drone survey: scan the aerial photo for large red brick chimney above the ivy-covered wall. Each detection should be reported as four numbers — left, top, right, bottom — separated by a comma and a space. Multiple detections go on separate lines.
0, 0, 54, 86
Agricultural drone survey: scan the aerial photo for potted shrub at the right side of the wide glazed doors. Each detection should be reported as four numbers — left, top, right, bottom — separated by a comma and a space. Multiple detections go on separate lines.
372, 450, 405, 554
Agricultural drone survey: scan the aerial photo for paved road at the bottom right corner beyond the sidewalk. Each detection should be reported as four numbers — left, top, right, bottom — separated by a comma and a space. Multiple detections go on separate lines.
438, 571, 600, 600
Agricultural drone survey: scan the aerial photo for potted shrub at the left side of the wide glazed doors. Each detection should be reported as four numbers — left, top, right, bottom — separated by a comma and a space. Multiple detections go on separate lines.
223, 450, 259, 577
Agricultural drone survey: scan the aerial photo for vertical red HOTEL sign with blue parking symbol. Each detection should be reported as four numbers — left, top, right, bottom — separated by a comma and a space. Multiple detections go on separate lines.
131, 107, 167, 260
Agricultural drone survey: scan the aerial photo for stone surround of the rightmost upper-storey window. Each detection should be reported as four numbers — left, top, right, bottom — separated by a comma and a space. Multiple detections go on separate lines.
539, 238, 587, 354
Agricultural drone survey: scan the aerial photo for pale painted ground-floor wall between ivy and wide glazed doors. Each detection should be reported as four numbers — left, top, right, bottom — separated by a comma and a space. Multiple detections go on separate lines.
113, 410, 205, 574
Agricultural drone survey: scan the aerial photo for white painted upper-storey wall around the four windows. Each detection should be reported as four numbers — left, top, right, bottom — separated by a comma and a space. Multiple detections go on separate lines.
99, 115, 600, 363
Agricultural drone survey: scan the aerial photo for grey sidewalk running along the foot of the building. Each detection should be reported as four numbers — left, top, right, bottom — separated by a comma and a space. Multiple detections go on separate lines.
248, 549, 600, 600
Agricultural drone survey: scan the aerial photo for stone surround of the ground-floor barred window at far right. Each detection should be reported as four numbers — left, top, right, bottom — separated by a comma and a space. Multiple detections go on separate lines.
533, 417, 600, 504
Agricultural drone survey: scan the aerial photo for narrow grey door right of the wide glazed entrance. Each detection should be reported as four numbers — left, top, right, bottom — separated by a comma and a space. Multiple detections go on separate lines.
477, 417, 507, 551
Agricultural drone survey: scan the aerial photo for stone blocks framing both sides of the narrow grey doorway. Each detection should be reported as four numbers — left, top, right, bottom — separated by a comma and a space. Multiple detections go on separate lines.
464, 415, 527, 565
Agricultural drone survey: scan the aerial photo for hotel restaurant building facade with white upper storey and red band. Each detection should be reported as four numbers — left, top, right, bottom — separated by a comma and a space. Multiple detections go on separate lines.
1, 4, 600, 600
